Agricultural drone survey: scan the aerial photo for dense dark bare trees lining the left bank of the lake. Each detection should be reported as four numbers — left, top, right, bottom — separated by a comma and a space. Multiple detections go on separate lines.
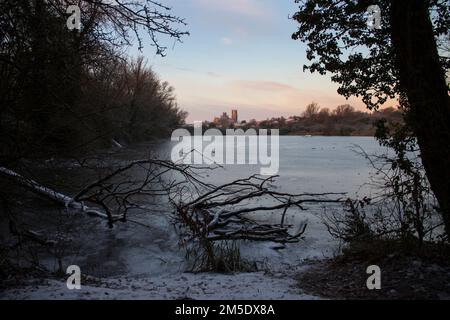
0, 0, 186, 162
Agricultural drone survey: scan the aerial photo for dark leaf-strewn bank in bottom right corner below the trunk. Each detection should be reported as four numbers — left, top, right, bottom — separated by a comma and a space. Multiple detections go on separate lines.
297, 241, 450, 300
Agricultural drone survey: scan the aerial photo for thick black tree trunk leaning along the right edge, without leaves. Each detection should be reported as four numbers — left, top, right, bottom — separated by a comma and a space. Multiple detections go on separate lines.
390, 0, 450, 239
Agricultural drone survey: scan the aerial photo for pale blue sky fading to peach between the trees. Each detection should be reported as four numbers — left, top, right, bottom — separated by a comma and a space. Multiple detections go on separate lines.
135, 0, 374, 122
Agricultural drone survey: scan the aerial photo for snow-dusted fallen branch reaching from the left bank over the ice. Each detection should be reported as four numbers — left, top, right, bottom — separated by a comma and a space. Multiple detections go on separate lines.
0, 159, 213, 227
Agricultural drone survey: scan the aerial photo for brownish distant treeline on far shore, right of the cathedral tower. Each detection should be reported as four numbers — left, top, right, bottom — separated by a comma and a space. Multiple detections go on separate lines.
239, 103, 403, 136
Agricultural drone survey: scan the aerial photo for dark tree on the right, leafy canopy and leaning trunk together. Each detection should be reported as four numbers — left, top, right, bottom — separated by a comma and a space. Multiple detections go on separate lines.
293, 0, 450, 237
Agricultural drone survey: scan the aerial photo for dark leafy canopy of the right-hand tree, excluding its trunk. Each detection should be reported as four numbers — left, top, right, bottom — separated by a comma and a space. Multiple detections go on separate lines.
292, 0, 450, 109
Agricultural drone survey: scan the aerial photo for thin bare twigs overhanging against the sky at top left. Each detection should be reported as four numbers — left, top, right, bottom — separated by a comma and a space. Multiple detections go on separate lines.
48, 0, 189, 56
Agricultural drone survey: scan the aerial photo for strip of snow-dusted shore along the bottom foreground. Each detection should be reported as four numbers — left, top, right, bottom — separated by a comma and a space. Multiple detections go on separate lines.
0, 272, 318, 300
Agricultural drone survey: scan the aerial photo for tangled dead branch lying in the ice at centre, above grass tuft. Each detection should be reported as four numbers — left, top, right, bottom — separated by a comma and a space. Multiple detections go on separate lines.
173, 175, 342, 243
